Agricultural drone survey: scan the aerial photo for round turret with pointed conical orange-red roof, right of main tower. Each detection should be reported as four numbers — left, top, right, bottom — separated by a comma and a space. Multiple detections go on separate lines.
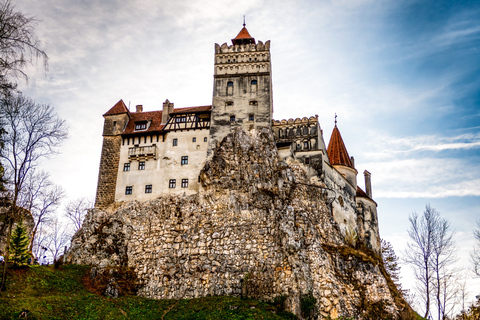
327, 120, 358, 189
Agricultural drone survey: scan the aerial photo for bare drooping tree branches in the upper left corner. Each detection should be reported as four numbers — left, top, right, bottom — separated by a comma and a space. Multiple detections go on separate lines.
0, 0, 48, 92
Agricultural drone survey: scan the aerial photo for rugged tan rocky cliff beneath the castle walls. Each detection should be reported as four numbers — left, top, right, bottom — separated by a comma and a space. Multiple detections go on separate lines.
67, 128, 410, 319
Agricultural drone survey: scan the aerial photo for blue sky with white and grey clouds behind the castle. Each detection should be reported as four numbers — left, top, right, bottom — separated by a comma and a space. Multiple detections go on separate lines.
11, 0, 480, 316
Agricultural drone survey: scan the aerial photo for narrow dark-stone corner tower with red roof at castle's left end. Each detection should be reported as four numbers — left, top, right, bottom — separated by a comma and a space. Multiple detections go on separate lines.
95, 100, 130, 208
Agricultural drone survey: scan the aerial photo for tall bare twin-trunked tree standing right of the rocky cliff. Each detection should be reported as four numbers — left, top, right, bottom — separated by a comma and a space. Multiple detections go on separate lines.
405, 204, 455, 319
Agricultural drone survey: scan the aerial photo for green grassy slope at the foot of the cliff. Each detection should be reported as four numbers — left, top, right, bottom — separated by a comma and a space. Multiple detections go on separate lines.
0, 265, 295, 320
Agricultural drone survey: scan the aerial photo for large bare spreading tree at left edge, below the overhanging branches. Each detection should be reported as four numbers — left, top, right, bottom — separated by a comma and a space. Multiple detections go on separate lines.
0, 93, 67, 290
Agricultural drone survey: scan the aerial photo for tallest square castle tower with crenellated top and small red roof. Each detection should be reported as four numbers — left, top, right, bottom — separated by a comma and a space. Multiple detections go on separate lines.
207, 23, 273, 158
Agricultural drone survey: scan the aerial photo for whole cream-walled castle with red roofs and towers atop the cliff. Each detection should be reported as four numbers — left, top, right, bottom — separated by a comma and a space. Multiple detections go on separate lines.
95, 24, 380, 255
